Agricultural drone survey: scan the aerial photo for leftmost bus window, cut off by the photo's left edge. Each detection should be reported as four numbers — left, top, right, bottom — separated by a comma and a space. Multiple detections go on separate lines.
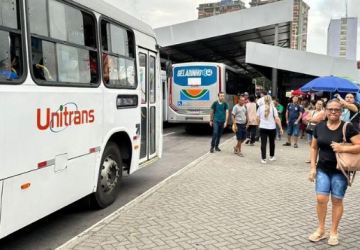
0, 0, 23, 83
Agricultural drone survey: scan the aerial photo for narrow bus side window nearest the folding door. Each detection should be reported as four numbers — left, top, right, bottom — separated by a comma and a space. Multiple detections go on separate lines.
101, 20, 136, 88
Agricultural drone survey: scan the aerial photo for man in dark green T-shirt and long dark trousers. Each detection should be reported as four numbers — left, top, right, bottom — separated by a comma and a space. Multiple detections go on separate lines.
210, 92, 229, 153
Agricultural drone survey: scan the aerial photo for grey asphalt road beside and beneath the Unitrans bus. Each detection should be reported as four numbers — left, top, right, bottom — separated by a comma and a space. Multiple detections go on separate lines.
0, 125, 232, 250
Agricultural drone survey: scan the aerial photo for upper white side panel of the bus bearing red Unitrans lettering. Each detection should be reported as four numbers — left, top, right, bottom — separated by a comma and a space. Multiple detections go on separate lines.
0, 85, 103, 179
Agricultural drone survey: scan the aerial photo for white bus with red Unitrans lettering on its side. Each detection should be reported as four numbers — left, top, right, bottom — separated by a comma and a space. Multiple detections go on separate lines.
0, 0, 162, 238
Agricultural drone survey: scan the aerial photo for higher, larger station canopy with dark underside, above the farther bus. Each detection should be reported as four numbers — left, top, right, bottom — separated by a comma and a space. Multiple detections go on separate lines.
155, 0, 294, 77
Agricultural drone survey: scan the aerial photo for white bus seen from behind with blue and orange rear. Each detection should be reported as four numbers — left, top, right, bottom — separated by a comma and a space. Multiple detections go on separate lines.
168, 62, 251, 123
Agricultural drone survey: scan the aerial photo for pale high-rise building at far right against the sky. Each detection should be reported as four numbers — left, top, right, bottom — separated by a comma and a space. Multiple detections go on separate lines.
327, 17, 357, 60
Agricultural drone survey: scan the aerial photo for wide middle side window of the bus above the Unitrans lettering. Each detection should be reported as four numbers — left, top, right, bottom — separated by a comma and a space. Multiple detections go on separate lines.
28, 0, 98, 86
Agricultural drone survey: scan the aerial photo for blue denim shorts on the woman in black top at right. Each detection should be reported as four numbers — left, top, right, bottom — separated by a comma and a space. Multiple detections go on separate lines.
315, 168, 348, 200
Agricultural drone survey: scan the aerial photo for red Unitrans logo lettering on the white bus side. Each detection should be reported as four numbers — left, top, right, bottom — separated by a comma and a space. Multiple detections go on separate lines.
36, 102, 95, 133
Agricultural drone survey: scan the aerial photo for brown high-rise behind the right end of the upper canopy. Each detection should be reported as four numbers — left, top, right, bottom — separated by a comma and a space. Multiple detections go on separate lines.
249, 0, 310, 50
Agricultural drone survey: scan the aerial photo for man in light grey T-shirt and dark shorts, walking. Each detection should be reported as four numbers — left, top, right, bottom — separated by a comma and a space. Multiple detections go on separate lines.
232, 96, 249, 157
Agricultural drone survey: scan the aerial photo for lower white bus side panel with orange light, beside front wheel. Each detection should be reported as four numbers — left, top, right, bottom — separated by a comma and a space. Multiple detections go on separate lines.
0, 153, 98, 238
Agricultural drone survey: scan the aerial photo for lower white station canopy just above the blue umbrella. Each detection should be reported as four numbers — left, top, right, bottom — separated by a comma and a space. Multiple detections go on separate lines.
245, 42, 360, 89
